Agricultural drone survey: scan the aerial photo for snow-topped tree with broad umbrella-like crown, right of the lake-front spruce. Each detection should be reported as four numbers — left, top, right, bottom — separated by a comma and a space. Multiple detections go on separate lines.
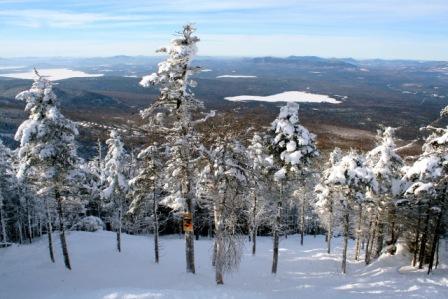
324, 150, 378, 273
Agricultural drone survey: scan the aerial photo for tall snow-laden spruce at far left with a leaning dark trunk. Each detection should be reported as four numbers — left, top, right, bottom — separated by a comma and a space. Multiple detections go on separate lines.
15, 71, 82, 269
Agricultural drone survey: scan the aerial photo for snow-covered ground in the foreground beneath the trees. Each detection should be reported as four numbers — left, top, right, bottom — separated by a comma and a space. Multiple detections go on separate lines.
0, 231, 448, 299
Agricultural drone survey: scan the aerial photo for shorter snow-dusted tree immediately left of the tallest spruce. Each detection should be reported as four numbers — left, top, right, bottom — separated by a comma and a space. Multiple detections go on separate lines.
128, 143, 163, 263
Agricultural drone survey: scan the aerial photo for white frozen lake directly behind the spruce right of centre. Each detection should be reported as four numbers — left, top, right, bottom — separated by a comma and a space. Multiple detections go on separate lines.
225, 91, 341, 104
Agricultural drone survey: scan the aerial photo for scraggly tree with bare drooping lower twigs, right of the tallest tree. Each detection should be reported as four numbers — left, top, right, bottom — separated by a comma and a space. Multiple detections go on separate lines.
197, 136, 249, 284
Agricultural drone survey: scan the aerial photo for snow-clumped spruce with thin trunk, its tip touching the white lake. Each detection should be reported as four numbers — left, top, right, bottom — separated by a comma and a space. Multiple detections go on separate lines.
269, 103, 319, 273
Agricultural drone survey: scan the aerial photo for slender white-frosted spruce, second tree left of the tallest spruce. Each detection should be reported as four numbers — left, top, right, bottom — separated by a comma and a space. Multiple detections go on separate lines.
101, 130, 129, 252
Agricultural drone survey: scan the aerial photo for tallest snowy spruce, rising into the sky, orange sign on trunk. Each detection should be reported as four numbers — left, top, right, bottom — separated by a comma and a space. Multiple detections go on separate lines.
140, 24, 202, 273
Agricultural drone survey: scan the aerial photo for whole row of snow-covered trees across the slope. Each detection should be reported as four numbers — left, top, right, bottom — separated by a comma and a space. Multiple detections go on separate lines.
0, 25, 448, 284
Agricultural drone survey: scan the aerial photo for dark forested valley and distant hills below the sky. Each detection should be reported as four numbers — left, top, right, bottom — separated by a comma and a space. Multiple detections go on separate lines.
0, 56, 448, 154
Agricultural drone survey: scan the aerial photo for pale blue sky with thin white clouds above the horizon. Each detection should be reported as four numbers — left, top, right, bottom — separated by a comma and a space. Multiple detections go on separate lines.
0, 0, 448, 60
